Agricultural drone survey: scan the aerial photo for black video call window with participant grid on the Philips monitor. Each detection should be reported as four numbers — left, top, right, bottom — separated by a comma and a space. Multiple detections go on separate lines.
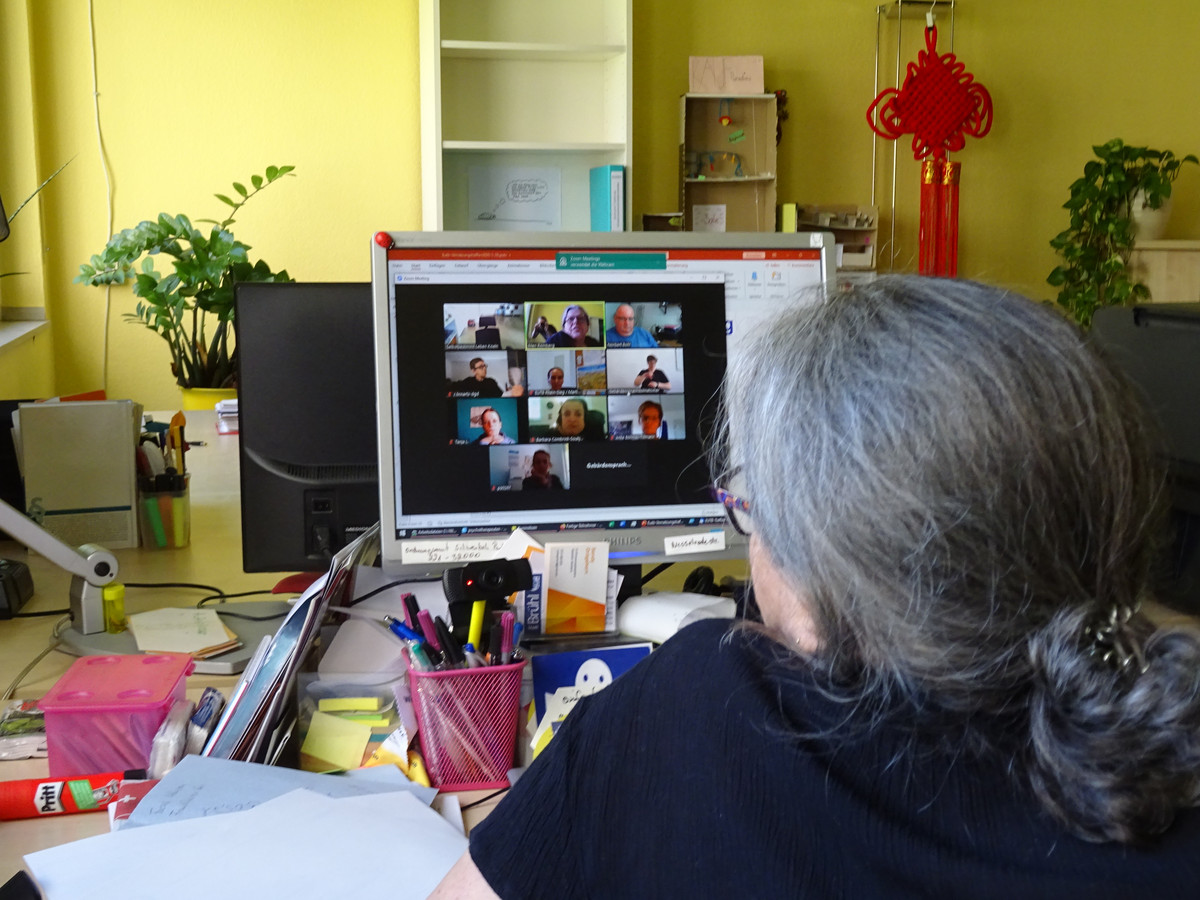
394, 281, 725, 533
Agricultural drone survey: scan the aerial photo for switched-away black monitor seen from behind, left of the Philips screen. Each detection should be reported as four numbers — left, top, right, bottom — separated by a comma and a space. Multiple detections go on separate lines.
235, 282, 379, 572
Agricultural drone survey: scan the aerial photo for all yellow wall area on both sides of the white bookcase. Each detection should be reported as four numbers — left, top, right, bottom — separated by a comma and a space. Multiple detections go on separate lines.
7, 0, 1200, 408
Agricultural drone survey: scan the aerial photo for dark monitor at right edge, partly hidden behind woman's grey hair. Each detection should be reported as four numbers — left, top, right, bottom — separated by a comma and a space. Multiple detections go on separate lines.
1091, 304, 1200, 613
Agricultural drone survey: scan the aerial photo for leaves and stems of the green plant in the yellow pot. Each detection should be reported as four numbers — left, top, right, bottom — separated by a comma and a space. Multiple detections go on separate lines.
76, 166, 295, 388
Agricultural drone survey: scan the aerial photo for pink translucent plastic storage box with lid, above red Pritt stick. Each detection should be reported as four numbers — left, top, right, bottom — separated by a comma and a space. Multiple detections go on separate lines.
38, 653, 196, 778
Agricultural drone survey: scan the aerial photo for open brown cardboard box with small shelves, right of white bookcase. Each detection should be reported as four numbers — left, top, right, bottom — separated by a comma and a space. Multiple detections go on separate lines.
679, 94, 779, 232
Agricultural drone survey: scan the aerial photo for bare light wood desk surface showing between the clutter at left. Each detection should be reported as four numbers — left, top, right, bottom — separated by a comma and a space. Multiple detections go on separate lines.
0, 410, 280, 883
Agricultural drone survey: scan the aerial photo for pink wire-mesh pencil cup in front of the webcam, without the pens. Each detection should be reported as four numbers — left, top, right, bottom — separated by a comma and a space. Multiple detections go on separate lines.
408, 660, 524, 791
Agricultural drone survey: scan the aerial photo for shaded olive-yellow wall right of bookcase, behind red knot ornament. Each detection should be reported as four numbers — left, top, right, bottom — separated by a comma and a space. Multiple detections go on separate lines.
632, 0, 1200, 298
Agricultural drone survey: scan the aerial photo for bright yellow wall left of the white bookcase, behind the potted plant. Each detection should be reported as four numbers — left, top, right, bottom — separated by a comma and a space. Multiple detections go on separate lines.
0, 0, 420, 409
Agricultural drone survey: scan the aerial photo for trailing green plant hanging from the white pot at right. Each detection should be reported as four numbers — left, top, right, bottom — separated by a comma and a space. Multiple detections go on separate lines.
1046, 138, 1196, 328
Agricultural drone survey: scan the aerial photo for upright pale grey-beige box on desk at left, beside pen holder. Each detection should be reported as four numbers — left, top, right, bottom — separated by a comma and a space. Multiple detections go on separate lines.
14, 400, 142, 550
